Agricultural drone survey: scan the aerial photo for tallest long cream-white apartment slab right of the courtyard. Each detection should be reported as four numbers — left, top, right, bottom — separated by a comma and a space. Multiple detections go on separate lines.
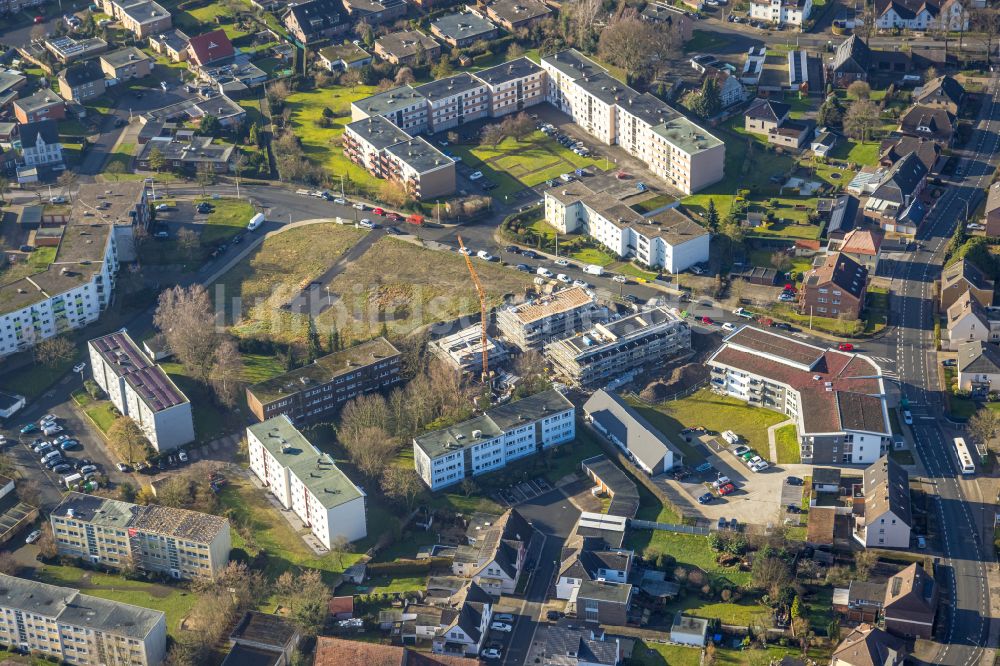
541, 49, 726, 194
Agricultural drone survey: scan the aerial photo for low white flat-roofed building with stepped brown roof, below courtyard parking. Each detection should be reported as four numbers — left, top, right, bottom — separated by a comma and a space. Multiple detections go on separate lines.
544, 174, 711, 273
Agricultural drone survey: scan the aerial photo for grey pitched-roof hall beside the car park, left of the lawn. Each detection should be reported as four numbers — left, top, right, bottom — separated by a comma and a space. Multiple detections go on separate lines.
583, 389, 684, 476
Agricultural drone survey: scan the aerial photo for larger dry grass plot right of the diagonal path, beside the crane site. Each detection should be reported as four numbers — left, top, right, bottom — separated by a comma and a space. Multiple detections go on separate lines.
316, 237, 531, 340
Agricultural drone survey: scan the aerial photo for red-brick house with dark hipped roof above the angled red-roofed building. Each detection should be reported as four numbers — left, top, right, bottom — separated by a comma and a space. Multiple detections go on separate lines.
799, 252, 868, 319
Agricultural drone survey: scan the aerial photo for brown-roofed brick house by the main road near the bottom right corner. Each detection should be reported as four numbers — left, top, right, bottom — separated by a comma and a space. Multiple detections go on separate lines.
882, 563, 938, 638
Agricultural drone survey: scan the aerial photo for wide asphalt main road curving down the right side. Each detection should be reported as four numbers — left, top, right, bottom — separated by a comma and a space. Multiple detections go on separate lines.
883, 79, 1000, 666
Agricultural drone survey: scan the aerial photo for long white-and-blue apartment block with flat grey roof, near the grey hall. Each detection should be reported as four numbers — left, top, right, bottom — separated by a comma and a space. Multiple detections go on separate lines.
413, 389, 576, 490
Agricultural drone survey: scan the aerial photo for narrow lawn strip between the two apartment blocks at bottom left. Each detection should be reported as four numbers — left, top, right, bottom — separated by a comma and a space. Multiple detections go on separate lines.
37, 564, 198, 636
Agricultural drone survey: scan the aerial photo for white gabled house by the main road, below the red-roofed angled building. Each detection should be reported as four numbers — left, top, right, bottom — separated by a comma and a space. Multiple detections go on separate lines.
854, 456, 913, 548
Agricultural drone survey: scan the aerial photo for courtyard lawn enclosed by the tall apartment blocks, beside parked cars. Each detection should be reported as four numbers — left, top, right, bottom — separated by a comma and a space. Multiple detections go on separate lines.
451, 132, 600, 197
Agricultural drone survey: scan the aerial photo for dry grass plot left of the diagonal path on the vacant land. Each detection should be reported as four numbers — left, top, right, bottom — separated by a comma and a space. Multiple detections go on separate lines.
212, 223, 367, 341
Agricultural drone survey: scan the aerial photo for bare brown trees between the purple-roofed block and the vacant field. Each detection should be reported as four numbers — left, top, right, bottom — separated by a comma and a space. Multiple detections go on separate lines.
153, 284, 243, 407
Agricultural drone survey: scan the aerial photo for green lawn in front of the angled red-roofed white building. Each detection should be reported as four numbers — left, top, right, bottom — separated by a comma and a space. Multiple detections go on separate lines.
638, 389, 788, 460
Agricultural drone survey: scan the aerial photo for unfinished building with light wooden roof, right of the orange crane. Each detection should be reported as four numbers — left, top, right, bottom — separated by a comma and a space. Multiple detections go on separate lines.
496, 287, 608, 351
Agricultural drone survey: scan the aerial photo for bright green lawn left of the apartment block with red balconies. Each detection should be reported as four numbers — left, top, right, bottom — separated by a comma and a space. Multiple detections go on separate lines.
285, 86, 381, 192
